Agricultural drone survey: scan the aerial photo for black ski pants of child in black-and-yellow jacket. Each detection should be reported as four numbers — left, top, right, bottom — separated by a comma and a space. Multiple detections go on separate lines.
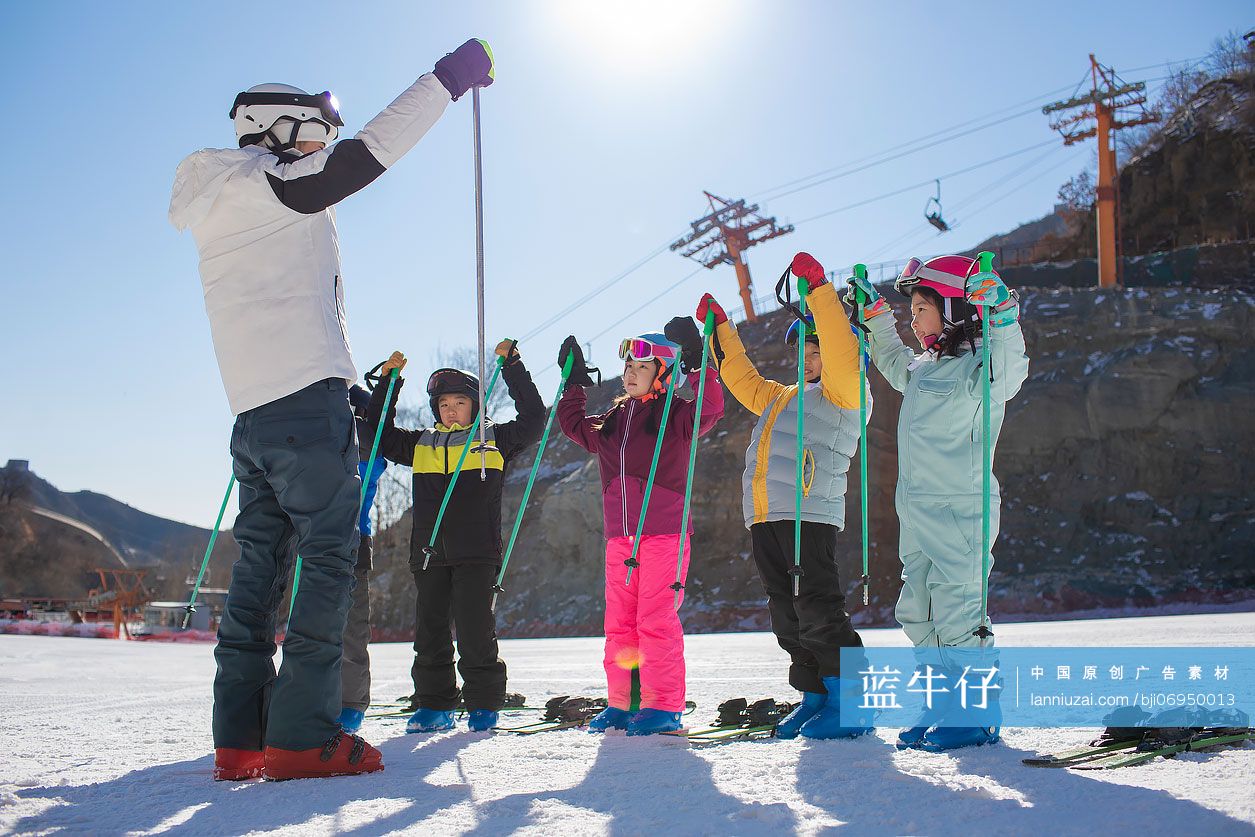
410, 563, 506, 710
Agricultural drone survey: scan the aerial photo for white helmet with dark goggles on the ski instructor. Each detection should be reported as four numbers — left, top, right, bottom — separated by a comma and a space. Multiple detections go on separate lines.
228, 84, 344, 151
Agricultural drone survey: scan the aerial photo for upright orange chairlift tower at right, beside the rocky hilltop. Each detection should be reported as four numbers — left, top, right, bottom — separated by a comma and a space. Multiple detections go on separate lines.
1042, 53, 1160, 287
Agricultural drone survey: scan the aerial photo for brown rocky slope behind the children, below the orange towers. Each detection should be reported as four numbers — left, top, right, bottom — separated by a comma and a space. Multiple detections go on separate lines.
373, 289, 1255, 636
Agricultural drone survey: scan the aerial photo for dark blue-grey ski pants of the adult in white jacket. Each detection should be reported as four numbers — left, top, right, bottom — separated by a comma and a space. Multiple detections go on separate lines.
213, 379, 361, 750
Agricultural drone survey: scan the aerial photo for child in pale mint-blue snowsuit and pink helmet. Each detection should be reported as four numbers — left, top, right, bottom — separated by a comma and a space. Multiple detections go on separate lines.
846, 250, 1028, 749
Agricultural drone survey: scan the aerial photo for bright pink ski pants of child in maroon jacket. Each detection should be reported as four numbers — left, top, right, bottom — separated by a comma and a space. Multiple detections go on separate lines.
604, 535, 689, 712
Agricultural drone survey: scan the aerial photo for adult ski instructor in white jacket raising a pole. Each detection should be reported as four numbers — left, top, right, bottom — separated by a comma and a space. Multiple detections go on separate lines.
169, 40, 493, 781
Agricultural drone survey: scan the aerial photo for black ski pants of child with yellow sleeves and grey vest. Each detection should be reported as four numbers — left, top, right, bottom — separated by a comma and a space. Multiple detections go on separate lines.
749, 521, 862, 694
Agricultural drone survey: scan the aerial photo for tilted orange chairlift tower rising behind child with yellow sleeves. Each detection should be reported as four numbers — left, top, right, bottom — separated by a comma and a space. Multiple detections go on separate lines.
671, 192, 793, 323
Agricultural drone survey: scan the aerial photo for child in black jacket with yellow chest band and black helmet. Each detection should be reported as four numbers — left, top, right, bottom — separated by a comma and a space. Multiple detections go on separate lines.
368, 340, 545, 733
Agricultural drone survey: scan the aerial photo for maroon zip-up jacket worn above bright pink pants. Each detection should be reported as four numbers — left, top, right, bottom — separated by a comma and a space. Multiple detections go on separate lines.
557, 369, 723, 538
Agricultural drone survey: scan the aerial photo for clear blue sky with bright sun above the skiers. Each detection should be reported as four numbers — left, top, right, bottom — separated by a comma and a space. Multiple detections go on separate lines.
0, 0, 1251, 525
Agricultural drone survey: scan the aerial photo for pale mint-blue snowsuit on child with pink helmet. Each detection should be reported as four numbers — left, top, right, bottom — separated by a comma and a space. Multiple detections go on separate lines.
867, 304, 1028, 649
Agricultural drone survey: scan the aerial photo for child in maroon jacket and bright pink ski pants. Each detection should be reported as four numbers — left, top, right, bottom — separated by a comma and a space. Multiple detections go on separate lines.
557, 317, 723, 735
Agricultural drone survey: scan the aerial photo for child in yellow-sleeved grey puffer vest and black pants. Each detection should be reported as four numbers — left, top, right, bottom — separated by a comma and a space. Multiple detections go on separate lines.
697, 252, 871, 738
